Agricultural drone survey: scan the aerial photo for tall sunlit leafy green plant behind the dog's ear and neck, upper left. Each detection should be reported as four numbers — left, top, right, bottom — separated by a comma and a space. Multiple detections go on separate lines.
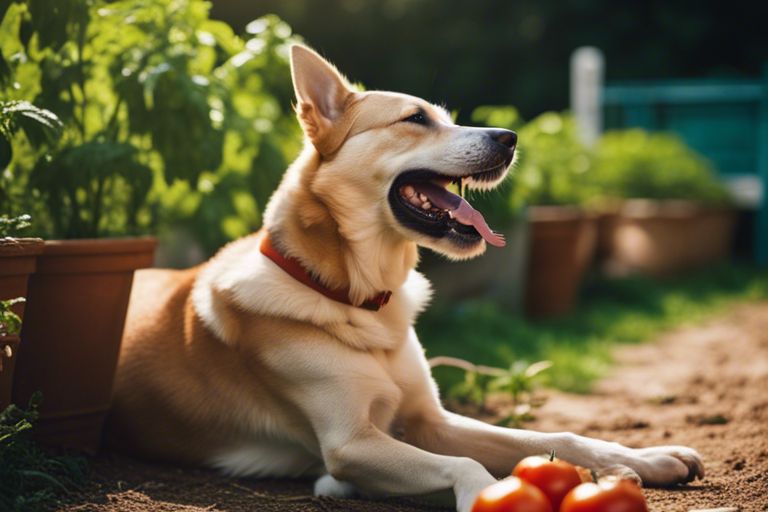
0, 0, 300, 248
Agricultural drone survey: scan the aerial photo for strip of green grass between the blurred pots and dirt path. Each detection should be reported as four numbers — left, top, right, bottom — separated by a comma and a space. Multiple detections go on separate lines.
416, 266, 768, 392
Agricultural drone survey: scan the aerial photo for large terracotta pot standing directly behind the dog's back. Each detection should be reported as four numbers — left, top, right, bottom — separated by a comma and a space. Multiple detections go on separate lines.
13, 238, 156, 452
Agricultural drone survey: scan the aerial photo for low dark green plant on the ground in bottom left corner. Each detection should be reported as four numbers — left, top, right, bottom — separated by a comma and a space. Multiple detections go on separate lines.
0, 393, 86, 512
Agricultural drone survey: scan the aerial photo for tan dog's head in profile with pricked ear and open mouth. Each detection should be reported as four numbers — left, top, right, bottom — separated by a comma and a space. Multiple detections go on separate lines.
291, 45, 517, 259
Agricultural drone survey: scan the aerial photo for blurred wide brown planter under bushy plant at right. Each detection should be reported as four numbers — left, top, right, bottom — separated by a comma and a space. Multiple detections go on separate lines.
605, 199, 736, 276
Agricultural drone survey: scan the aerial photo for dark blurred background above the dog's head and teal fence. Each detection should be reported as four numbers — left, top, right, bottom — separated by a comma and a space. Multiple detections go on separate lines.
211, 0, 768, 122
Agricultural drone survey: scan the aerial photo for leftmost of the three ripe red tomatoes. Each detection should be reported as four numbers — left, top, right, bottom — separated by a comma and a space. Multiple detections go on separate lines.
472, 476, 553, 512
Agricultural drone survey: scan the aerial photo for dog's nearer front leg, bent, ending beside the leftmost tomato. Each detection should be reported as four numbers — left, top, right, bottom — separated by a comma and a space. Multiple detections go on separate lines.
272, 340, 496, 512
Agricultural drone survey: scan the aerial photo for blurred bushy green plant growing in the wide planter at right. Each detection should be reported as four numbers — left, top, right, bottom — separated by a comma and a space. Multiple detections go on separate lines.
590, 129, 728, 204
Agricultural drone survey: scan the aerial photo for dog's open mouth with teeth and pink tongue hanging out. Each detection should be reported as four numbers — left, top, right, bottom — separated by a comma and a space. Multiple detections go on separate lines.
389, 165, 506, 247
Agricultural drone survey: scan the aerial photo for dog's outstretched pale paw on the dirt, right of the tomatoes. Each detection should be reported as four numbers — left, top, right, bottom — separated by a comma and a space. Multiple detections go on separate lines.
625, 446, 704, 486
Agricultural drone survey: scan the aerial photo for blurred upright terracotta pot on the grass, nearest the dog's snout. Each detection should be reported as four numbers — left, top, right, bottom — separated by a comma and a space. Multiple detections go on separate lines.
525, 206, 596, 317
